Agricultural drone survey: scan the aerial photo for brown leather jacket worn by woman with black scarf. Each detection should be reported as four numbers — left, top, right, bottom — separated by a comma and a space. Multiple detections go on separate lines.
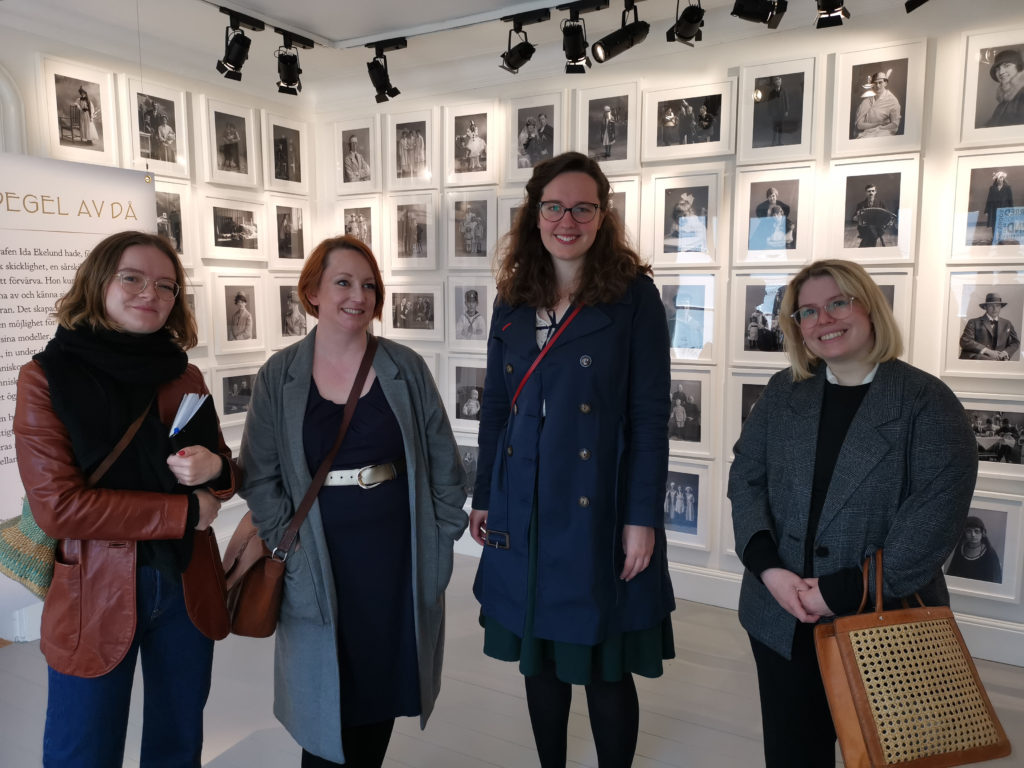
14, 360, 241, 677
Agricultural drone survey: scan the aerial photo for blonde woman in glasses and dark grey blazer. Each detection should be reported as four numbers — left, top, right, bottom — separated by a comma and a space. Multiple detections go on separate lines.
729, 260, 978, 768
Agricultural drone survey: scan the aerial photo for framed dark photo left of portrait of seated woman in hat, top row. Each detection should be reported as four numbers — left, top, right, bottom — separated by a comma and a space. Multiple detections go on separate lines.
736, 58, 816, 163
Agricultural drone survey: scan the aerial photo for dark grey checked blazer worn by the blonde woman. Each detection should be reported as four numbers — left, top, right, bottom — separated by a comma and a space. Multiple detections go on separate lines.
729, 360, 978, 658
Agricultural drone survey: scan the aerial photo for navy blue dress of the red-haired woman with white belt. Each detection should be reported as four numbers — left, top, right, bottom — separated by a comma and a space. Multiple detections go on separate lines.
302, 380, 420, 726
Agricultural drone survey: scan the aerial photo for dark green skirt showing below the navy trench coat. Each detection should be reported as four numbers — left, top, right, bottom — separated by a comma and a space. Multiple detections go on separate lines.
480, 505, 676, 685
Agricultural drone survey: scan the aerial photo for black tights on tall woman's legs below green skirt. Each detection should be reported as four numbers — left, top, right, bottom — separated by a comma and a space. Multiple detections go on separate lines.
526, 662, 640, 768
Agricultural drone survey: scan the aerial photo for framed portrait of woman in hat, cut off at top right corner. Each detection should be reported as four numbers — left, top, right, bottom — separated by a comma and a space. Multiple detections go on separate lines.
961, 27, 1024, 146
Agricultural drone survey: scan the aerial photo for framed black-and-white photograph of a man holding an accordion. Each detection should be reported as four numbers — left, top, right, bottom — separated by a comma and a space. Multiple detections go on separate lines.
825, 155, 921, 264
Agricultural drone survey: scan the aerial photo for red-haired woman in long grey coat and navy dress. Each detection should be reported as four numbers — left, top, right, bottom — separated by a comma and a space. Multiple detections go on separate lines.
239, 236, 467, 768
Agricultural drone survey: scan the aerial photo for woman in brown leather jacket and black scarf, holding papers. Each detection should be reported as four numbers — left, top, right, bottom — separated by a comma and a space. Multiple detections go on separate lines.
14, 231, 239, 768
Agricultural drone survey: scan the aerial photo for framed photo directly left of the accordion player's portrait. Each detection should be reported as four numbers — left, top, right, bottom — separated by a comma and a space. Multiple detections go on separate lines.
732, 163, 815, 264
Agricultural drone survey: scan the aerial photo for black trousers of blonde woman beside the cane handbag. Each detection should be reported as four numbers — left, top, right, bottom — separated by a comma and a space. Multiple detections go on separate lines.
751, 624, 836, 768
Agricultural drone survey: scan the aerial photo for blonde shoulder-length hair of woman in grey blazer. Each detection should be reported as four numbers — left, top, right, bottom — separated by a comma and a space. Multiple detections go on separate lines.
778, 259, 903, 381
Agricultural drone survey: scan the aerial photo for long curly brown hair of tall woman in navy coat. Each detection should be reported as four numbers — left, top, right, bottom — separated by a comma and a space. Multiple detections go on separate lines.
497, 152, 651, 307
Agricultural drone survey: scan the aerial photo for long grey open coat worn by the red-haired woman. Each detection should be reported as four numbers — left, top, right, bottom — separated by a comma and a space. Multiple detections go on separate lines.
239, 329, 467, 763
